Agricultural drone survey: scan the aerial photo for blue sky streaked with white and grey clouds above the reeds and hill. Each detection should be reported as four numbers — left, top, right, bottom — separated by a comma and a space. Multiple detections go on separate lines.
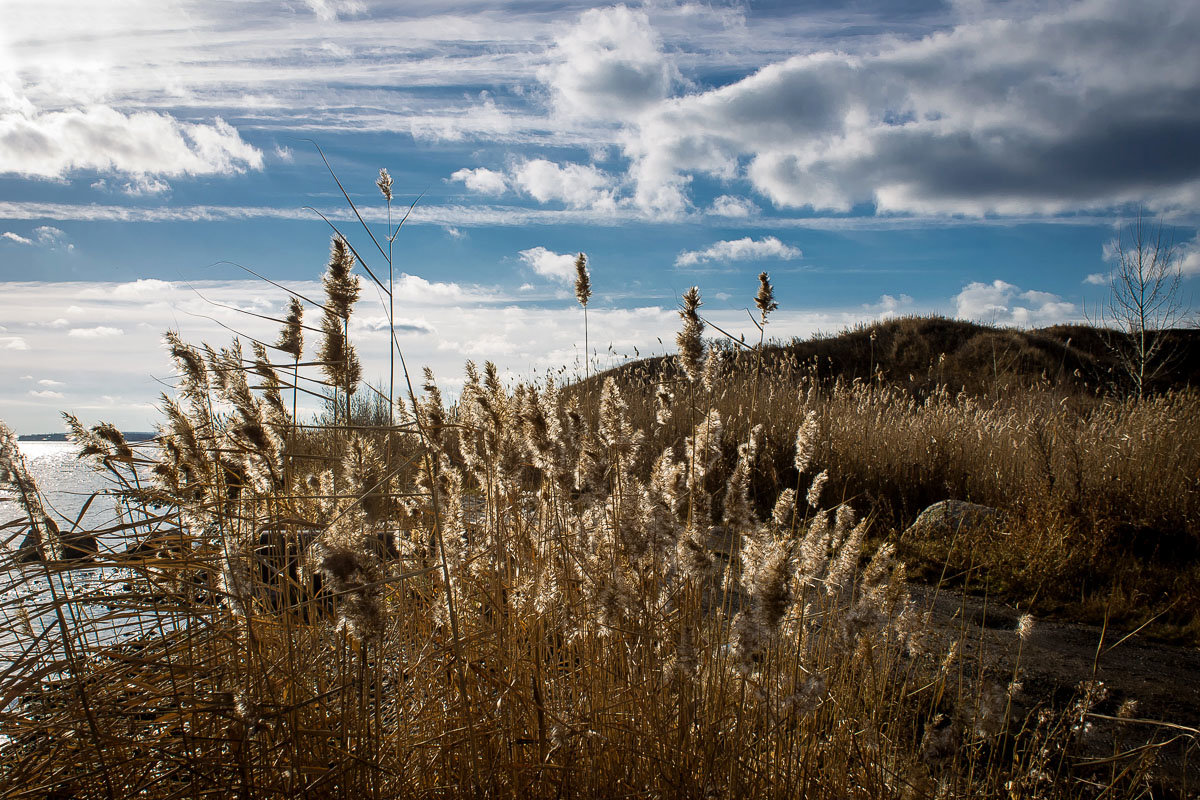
0, 0, 1200, 433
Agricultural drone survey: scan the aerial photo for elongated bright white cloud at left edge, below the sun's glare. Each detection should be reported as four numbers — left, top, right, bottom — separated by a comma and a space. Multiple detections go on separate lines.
0, 103, 263, 179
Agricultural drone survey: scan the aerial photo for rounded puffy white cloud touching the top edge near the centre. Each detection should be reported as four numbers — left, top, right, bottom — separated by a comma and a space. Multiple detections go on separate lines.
538, 5, 679, 120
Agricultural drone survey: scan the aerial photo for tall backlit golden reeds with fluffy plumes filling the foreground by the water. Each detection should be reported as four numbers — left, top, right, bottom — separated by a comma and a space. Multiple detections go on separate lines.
0, 175, 1190, 798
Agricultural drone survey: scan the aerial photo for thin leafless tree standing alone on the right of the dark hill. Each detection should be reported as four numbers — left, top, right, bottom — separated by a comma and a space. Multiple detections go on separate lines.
1100, 213, 1187, 397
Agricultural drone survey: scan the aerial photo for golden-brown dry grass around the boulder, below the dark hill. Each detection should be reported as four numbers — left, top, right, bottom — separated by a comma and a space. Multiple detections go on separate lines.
584, 347, 1200, 642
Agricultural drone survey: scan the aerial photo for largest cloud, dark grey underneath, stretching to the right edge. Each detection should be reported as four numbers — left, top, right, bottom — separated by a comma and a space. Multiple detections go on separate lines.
625, 0, 1200, 215
